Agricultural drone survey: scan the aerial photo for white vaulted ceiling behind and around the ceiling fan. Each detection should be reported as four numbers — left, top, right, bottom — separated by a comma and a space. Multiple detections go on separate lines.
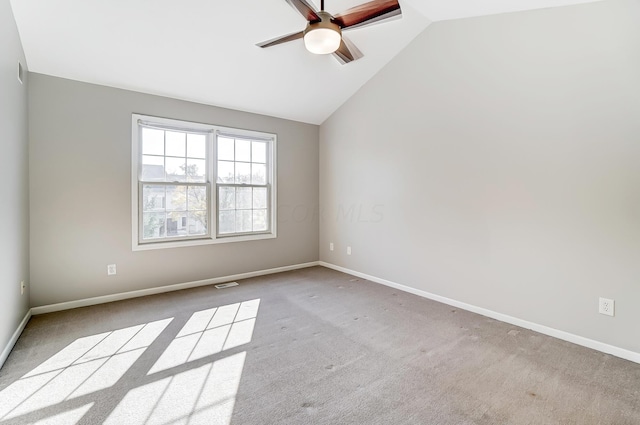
11, 0, 592, 124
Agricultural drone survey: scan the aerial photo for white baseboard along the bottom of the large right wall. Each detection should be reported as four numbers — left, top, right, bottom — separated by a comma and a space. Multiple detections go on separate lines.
319, 261, 640, 363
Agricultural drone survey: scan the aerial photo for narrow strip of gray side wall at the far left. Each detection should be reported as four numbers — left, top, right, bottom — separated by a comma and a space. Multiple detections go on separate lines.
0, 0, 29, 358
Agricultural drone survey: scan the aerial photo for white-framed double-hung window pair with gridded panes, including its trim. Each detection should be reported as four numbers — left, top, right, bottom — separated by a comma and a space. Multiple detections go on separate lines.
132, 114, 276, 250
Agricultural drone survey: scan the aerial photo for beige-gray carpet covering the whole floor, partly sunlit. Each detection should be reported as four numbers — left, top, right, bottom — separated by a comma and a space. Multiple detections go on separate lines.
0, 267, 640, 425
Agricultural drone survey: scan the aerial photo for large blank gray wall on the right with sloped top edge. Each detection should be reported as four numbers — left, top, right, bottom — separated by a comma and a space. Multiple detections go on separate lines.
320, 0, 640, 352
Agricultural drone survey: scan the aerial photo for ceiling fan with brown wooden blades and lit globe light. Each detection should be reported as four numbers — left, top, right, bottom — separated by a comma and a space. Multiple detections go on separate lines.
257, 0, 402, 64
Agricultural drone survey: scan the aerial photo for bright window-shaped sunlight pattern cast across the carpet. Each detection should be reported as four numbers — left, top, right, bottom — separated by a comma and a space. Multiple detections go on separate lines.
0, 299, 260, 425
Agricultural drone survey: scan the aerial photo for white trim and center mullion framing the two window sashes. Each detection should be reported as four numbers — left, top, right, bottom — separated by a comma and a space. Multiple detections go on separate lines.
131, 114, 278, 251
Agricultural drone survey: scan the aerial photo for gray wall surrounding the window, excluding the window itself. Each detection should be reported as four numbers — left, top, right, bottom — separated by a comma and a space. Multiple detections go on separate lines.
29, 74, 319, 306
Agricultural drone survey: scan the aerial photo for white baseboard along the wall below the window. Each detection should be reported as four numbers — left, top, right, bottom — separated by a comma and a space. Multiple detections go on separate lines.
31, 261, 320, 316
